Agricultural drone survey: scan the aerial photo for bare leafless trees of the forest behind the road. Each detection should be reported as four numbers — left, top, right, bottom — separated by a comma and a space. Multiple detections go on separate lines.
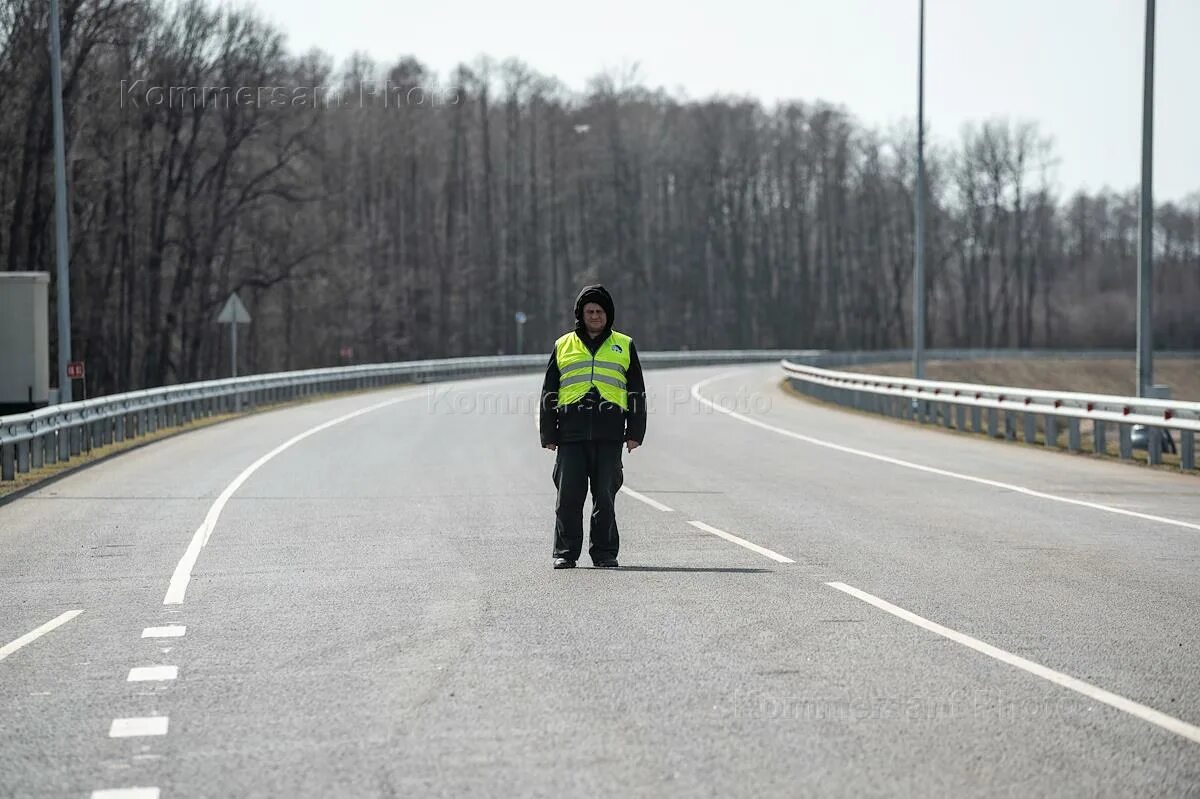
0, 0, 1200, 394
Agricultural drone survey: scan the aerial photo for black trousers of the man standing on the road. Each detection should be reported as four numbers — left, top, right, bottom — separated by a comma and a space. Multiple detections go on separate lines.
553, 441, 625, 563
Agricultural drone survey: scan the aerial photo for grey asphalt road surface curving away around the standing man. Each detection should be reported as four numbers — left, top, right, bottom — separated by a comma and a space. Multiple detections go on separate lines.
0, 367, 1200, 797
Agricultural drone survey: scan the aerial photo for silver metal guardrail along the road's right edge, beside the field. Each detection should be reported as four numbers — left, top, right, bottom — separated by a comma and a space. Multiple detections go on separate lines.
780, 354, 1200, 471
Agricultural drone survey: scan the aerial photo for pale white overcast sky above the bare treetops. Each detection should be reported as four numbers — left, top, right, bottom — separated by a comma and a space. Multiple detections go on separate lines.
248, 0, 1200, 202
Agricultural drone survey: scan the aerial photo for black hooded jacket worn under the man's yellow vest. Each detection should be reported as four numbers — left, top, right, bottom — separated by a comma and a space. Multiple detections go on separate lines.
539, 284, 646, 446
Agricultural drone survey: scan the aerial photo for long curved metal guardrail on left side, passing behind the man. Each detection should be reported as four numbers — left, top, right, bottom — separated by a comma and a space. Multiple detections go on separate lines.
0, 350, 815, 481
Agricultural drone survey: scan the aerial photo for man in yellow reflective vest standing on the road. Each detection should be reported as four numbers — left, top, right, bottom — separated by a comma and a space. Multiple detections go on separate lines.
540, 284, 646, 569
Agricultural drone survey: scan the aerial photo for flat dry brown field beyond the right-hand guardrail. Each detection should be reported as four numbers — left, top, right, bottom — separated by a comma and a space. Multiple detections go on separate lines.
848, 358, 1200, 401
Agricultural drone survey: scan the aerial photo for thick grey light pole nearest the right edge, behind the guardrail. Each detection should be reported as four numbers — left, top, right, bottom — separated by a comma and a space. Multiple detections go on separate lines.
1138, 0, 1154, 397
